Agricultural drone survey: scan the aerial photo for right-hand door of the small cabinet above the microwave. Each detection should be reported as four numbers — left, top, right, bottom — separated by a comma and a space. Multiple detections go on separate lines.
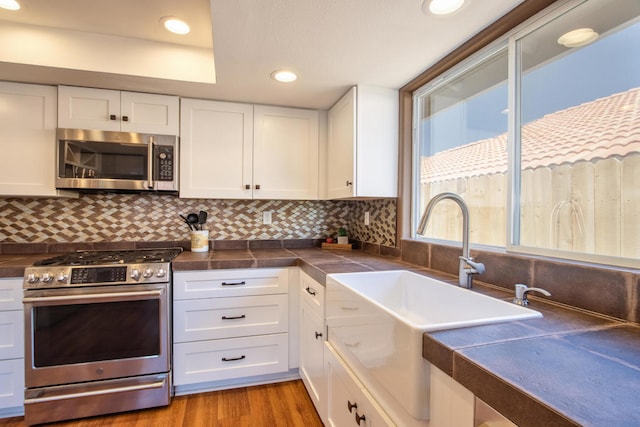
120, 92, 180, 135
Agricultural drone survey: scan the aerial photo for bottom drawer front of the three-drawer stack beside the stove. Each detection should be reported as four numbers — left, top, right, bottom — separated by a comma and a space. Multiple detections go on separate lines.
173, 333, 289, 386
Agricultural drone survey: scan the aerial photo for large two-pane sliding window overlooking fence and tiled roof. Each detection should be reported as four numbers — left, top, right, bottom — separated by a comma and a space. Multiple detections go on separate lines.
413, 0, 640, 266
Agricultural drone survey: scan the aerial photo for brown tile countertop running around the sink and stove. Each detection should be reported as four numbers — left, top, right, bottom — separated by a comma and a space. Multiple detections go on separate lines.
0, 248, 640, 427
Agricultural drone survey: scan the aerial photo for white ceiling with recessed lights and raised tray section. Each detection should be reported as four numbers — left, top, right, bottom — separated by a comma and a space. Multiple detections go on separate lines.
0, 0, 522, 109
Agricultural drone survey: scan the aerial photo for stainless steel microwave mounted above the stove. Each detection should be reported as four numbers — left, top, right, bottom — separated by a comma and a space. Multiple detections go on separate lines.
56, 129, 178, 193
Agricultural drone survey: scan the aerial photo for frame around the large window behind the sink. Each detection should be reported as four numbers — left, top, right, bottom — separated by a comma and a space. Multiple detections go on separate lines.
410, 0, 640, 268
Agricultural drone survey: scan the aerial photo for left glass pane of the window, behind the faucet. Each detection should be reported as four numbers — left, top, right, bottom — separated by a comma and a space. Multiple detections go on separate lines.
413, 44, 508, 247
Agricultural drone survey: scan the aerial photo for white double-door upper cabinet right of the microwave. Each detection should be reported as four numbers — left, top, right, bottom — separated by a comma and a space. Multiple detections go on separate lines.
180, 99, 318, 199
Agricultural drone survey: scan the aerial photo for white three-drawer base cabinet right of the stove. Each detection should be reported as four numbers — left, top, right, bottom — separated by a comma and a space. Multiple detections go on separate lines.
173, 268, 297, 394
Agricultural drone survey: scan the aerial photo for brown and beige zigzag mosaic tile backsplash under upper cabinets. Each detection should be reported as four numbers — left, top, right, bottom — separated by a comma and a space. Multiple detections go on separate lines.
0, 193, 396, 246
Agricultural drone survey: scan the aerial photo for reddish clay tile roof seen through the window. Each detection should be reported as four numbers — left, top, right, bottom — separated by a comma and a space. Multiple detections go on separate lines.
420, 88, 640, 183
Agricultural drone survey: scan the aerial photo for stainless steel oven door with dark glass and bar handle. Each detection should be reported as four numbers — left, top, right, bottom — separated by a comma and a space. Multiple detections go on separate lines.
23, 283, 170, 388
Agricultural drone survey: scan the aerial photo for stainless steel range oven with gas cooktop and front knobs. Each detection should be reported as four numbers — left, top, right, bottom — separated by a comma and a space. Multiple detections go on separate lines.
23, 248, 182, 425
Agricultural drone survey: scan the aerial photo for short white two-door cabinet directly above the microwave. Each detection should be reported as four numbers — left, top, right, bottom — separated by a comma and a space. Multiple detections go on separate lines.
58, 86, 179, 135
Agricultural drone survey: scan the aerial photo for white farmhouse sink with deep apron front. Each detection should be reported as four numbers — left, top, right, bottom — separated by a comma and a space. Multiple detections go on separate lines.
326, 271, 542, 426
